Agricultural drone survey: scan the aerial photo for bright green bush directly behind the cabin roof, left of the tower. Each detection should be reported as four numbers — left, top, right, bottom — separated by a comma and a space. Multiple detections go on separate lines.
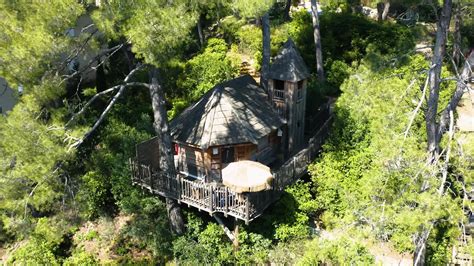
178, 38, 240, 102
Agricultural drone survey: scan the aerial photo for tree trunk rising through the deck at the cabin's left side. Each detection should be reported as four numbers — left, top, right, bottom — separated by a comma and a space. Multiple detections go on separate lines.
150, 69, 184, 235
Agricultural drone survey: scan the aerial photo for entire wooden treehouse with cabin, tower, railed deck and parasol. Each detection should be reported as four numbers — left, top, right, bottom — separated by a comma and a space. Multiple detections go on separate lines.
130, 40, 331, 223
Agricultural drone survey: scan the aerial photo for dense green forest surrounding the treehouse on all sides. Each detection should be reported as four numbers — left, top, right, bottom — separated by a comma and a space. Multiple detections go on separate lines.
0, 0, 474, 265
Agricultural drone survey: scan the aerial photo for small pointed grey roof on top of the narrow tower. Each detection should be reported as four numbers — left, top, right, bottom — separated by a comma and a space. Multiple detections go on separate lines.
268, 39, 310, 82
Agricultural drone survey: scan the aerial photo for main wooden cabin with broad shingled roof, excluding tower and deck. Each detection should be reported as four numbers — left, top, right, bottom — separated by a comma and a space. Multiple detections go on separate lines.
170, 75, 286, 182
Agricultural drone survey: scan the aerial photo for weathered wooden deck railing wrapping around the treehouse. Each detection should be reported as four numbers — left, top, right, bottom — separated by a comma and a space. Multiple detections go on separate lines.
130, 117, 333, 224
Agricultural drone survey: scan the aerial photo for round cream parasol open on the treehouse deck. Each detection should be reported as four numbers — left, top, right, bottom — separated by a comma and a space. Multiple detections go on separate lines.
222, 161, 273, 193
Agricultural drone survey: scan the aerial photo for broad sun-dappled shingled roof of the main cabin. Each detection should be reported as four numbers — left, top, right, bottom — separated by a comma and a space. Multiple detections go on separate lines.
170, 75, 284, 149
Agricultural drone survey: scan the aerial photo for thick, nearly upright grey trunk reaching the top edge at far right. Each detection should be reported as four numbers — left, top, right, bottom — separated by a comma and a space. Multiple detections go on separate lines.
425, 0, 452, 162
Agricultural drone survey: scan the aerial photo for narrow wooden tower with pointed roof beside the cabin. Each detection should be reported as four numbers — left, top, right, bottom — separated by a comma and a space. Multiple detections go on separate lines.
268, 39, 310, 156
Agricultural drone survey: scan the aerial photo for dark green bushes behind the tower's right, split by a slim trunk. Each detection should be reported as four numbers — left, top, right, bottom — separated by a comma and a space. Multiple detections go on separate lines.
286, 10, 415, 79
